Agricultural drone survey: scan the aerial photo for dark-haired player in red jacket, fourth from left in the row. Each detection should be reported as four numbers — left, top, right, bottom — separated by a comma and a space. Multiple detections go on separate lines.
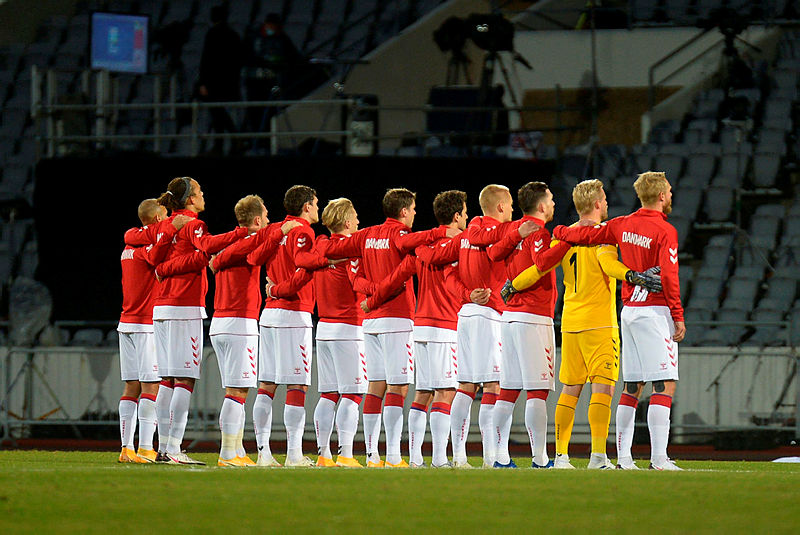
247, 185, 328, 466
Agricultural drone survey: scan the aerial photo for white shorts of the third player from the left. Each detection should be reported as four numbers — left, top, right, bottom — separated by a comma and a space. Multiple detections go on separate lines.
211, 334, 258, 388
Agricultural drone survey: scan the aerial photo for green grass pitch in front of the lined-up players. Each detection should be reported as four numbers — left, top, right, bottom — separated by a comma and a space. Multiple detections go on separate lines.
0, 451, 800, 535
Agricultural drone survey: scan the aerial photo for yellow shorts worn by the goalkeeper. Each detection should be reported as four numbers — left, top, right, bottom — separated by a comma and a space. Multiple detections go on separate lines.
558, 327, 619, 385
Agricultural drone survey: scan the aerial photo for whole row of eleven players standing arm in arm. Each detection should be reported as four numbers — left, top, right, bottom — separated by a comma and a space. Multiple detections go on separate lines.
118, 172, 686, 470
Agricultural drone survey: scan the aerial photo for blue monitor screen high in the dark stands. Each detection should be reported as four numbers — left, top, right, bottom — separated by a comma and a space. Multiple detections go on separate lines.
91, 13, 148, 74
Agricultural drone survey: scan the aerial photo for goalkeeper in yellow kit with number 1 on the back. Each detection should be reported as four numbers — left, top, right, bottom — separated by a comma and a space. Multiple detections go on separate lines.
501, 179, 661, 469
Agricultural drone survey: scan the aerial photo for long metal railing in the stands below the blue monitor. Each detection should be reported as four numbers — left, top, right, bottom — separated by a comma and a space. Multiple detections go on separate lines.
31, 66, 585, 158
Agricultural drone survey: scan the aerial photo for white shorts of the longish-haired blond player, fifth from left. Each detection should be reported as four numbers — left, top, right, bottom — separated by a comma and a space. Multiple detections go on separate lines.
317, 340, 367, 394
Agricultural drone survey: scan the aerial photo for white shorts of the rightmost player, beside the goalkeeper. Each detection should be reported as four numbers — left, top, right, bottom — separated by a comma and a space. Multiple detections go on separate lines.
620, 306, 678, 383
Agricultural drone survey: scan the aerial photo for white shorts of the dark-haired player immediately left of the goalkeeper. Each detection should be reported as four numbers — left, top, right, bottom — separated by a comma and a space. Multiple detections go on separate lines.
500, 321, 556, 390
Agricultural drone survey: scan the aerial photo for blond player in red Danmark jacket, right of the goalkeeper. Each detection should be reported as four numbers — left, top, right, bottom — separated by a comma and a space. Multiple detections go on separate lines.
553, 171, 686, 470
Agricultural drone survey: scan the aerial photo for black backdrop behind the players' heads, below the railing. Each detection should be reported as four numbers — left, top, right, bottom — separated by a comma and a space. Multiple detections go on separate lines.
34, 155, 560, 321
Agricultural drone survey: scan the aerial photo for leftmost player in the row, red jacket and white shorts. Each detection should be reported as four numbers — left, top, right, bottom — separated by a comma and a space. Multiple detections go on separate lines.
117, 199, 188, 463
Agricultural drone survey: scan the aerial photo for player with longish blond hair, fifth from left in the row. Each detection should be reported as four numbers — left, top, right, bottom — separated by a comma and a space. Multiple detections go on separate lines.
314, 198, 371, 468
